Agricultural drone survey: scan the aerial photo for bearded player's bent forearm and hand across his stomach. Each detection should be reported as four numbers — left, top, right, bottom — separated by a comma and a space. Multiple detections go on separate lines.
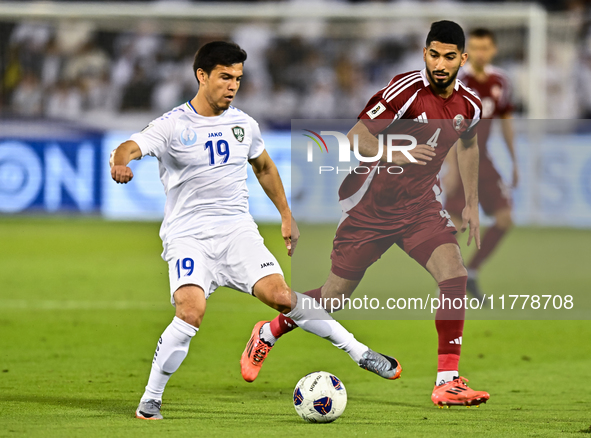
347, 120, 435, 166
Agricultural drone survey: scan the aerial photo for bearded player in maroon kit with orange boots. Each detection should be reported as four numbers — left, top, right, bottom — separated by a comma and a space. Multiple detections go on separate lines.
241, 21, 489, 406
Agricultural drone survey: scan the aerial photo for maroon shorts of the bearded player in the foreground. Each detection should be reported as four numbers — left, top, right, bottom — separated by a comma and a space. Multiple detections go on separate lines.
330, 202, 457, 280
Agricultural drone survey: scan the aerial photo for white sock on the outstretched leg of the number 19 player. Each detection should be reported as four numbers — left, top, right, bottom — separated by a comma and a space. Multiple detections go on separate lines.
285, 292, 369, 363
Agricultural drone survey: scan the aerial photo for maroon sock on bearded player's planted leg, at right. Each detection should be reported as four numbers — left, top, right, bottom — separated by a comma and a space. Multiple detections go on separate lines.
435, 276, 468, 371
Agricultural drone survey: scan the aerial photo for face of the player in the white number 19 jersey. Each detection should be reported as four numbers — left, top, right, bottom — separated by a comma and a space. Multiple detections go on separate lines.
201, 64, 243, 112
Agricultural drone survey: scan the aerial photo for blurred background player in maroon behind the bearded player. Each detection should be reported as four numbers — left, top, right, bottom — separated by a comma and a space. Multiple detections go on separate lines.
443, 28, 519, 299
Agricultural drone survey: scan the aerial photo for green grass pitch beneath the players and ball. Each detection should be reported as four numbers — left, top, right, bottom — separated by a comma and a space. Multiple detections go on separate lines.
0, 218, 591, 438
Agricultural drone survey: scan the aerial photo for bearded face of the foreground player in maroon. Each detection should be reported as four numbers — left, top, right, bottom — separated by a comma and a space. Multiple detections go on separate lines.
423, 41, 466, 90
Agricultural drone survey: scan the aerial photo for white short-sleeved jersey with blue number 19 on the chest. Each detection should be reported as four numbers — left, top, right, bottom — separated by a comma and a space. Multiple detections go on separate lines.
131, 102, 265, 245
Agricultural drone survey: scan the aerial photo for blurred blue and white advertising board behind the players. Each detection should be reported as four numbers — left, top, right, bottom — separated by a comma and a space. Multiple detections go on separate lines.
0, 122, 591, 227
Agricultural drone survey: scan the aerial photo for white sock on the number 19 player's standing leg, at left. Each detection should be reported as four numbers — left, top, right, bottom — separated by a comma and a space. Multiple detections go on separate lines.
142, 316, 199, 400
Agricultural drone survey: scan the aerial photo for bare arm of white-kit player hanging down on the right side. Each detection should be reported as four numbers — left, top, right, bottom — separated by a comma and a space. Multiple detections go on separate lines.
249, 151, 300, 256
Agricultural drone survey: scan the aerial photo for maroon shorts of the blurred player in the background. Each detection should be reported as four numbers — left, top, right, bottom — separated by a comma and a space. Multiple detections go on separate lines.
445, 157, 511, 216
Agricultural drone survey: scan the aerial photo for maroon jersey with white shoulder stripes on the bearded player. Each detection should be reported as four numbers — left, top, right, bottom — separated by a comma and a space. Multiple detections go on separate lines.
339, 70, 482, 229
